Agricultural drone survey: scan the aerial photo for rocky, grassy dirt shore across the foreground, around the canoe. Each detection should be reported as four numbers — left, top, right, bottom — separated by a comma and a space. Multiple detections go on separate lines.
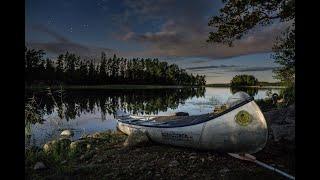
25, 105, 295, 179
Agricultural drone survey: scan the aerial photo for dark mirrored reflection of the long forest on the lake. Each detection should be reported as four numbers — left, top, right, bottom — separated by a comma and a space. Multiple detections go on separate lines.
25, 87, 205, 123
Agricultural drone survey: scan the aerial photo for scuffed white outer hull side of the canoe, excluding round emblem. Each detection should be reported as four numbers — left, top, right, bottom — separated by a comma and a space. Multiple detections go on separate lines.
117, 101, 268, 153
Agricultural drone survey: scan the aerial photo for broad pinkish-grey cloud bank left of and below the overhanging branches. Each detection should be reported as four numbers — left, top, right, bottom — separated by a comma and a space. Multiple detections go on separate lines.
120, 20, 288, 59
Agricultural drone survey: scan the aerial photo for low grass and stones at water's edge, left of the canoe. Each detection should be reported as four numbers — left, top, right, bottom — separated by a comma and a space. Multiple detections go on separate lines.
25, 131, 126, 178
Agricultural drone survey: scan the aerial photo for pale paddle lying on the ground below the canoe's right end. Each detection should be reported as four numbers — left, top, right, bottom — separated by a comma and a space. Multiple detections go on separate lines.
228, 153, 295, 179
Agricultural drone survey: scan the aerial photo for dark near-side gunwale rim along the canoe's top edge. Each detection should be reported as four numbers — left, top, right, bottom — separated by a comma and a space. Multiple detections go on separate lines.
118, 97, 254, 128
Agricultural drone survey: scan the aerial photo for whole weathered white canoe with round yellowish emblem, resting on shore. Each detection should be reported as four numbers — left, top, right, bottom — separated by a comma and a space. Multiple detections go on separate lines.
117, 92, 268, 153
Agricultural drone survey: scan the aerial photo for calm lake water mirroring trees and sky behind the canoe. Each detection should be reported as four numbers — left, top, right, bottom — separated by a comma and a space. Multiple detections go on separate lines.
25, 87, 279, 147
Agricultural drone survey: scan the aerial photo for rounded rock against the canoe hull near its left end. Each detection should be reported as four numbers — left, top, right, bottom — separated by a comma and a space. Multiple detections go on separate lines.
123, 130, 149, 147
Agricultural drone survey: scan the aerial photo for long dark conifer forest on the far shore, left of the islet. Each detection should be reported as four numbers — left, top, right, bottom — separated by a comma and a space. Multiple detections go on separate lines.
25, 48, 206, 86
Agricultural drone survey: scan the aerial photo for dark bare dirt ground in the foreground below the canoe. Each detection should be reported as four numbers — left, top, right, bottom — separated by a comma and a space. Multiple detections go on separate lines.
26, 130, 295, 179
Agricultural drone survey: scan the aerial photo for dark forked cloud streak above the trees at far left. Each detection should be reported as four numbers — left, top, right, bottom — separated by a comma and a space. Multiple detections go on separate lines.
26, 25, 116, 57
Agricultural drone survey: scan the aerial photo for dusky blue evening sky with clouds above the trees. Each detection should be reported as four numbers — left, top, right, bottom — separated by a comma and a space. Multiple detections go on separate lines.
25, 0, 288, 83
